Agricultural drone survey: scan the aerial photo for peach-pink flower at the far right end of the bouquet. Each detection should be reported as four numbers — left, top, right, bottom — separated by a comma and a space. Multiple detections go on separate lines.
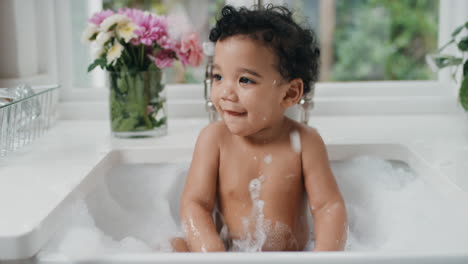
177, 32, 203, 66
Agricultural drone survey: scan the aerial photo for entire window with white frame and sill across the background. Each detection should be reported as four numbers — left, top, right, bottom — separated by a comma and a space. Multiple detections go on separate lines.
0, 0, 468, 113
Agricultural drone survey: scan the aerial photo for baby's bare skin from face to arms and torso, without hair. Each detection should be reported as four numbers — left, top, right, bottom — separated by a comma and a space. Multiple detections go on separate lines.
180, 36, 346, 251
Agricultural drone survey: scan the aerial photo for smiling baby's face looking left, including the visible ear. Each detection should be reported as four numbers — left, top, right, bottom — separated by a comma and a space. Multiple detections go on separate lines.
211, 36, 288, 136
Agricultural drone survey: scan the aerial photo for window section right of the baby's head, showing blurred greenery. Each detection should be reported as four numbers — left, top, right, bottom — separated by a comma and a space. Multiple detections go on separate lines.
285, 0, 439, 82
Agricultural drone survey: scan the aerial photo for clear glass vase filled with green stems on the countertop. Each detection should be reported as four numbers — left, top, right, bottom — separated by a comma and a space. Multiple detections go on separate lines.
109, 69, 167, 138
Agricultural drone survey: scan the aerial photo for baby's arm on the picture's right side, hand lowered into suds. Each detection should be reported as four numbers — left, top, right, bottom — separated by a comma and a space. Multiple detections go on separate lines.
301, 129, 347, 251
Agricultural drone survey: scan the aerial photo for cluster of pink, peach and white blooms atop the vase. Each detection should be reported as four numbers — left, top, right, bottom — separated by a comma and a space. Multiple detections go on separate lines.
83, 7, 203, 72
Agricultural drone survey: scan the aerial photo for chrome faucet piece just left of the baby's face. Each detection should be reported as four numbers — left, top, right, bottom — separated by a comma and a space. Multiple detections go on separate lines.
203, 42, 219, 123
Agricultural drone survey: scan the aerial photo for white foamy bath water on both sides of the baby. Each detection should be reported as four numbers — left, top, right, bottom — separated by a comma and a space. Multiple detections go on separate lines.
40, 157, 468, 258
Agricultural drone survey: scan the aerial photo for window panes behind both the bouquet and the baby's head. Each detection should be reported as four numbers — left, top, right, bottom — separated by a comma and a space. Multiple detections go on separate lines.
66, 0, 439, 90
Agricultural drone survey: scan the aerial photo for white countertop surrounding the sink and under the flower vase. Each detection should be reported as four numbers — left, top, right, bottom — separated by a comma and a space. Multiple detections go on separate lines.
0, 115, 468, 258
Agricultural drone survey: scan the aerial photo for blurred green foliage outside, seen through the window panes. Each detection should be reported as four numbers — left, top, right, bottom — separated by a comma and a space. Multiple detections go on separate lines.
103, 0, 439, 83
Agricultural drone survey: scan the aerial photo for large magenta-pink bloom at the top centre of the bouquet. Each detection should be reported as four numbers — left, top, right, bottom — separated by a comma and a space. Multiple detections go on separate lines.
119, 8, 170, 49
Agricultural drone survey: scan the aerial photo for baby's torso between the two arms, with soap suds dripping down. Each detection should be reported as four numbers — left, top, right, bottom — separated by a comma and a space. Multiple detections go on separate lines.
216, 120, 309, 251
